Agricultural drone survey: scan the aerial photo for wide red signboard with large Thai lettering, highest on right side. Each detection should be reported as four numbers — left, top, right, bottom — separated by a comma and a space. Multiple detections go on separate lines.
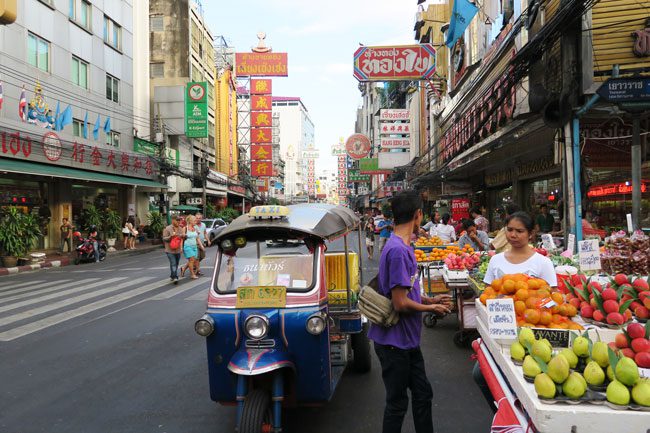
354, 44, 436, 81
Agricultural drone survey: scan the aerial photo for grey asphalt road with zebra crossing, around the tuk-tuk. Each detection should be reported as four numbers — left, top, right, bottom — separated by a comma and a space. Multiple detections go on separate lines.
0, 236, 492, 433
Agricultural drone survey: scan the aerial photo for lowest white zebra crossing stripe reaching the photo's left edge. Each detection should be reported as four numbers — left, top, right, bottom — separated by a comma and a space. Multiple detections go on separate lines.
0, 280, 202, 341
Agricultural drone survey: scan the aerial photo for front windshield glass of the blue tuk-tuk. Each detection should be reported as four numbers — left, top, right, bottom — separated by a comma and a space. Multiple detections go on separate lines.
215, 240, 315, 293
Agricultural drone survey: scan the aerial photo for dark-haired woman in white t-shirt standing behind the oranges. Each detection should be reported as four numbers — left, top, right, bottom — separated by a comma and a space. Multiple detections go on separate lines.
483, 212, 557, 287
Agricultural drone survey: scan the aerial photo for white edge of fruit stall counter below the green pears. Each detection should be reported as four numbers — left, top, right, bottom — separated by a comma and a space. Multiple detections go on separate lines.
470, 314, 650, 433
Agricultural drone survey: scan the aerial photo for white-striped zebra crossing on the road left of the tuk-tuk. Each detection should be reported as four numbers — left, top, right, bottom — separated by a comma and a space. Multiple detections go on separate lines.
0, 275, 209, 343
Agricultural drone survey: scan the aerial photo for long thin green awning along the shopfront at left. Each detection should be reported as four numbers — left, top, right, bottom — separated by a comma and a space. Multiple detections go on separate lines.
0, 158, 168, 188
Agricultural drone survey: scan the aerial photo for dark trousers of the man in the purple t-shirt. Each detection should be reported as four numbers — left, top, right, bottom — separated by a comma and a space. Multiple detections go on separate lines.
375, 343, 433, 433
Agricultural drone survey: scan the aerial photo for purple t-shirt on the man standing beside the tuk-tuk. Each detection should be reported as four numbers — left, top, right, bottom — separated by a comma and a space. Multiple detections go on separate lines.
368, 234, 422, 349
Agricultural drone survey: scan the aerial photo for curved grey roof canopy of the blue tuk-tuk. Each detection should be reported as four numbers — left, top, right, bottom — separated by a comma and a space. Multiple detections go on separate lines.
215, 203, 359, 242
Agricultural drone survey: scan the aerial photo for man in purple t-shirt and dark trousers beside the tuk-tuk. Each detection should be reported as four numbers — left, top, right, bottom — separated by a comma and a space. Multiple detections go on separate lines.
368, 191, 450, 433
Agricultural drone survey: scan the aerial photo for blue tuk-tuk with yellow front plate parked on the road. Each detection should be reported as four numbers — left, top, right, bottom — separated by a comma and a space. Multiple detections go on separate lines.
195, 204, 371, 433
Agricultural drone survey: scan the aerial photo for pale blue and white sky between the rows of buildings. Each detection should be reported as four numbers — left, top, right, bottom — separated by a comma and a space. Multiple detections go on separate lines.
201, 0, 417, 169
